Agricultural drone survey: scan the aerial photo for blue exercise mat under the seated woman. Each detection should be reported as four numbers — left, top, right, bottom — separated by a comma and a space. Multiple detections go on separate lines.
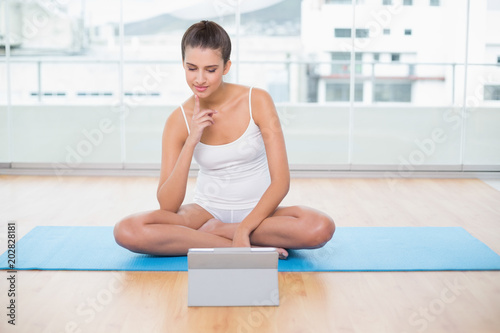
0, 227, 500, 272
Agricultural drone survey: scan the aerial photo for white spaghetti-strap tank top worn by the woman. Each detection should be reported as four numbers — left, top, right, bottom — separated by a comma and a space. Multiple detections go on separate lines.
181, 88, 271, 210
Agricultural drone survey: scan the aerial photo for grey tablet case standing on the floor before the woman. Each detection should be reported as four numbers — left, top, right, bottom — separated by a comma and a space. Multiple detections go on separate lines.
188, 247, 279, 306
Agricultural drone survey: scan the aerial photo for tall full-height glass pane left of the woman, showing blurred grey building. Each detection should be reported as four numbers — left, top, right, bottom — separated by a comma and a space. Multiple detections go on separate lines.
9, 0, 121, 166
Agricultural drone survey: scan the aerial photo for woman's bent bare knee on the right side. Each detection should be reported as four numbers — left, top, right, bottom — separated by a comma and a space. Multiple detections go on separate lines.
305, 209, 335, 249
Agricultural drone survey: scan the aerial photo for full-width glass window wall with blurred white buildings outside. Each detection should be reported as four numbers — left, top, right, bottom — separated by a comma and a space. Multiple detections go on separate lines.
0, 0, 500, 168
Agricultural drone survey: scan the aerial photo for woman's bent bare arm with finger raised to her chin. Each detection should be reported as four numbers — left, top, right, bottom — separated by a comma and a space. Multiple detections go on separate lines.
156, 96, 216, 212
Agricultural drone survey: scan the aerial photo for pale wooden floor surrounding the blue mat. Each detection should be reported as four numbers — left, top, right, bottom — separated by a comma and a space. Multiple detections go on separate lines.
0, 176, 500, 333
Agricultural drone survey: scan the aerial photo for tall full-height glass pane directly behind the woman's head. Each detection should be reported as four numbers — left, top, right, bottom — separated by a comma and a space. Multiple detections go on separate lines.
123, 0, 236, 167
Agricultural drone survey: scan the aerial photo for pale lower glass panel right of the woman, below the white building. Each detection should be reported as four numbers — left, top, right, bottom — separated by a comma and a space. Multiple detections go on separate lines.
352, 106, 460, 166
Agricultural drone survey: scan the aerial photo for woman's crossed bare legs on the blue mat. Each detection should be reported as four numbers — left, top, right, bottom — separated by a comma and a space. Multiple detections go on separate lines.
114, 204, 335, 256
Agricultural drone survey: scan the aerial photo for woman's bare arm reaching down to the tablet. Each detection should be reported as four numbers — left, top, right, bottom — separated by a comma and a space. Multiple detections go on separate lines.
233, 89, 290, 247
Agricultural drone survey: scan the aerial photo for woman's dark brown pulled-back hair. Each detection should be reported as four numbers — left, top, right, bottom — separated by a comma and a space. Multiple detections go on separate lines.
181, 20, 231, 65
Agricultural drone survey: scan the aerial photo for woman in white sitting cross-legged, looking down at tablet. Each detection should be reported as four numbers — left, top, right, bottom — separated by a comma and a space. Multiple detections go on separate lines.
114, 21, 335, 258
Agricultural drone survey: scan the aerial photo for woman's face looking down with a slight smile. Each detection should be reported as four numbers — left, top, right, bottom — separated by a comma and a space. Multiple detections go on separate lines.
183, 47, 231, 98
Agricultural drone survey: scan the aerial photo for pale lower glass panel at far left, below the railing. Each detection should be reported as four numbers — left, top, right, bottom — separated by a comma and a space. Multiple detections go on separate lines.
12, 105, 120, 166
